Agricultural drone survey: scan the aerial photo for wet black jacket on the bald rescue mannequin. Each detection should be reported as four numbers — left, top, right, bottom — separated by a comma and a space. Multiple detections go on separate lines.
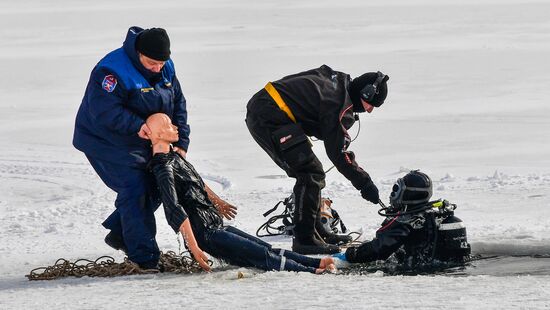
149, 151, 223, 232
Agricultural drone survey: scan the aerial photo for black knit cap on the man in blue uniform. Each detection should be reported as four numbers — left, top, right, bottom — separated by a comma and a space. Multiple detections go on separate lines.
136, 28, 170, 61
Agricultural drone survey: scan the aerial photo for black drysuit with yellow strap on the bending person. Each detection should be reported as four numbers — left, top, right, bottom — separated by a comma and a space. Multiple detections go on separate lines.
246, 65, 372, 240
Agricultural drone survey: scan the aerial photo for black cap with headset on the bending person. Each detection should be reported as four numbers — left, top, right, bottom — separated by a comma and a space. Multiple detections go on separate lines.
348, 71, 389, 112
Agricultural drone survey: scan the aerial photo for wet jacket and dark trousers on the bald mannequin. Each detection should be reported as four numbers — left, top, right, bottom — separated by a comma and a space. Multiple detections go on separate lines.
149, 151, 321, 273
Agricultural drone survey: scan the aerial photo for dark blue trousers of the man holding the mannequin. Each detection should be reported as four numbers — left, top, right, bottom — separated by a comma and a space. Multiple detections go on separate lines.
87, 156, 160, 264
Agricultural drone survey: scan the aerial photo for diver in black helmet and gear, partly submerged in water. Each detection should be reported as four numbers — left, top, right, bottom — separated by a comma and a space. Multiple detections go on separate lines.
334, 170, 470, 268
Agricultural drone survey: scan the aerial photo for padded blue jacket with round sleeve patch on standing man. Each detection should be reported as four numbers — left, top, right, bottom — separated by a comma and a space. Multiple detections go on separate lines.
73, 27, 190, 168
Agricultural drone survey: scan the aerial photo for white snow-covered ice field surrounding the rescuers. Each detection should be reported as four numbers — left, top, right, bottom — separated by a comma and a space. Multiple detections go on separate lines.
0, 0, 550, 309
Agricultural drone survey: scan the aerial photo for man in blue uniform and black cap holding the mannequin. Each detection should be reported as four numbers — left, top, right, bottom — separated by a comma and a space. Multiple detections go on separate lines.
73, 27, 189, 269
